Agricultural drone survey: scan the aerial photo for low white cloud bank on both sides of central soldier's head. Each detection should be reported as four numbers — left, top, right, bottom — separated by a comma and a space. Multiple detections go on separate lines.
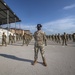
1, 16, 75, 34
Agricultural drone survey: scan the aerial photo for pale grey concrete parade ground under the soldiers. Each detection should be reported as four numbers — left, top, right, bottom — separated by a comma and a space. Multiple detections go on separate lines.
0, 40, 75, 75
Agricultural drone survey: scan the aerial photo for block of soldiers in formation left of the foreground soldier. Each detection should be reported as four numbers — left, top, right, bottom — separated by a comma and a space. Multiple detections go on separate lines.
2, 32, 33, 46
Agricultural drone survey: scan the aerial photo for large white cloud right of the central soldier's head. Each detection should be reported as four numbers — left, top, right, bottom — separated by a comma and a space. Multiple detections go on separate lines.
43, 17, 75, 34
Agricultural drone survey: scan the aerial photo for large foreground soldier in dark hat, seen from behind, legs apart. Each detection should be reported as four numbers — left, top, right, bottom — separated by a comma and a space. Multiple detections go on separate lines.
33, 24, 47, 66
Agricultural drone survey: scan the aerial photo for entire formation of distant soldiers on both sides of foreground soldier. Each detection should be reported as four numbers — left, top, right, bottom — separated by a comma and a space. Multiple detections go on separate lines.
2, 32, 75, 46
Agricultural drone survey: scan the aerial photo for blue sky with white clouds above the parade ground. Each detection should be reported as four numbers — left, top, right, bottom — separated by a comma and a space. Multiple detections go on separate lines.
4, 0, 75, 34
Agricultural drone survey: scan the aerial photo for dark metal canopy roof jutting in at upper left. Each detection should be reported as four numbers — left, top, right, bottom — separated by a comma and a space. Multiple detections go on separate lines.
0, 0, 21, 25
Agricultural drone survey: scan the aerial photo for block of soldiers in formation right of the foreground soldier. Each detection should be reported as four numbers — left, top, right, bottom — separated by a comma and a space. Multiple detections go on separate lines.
47, 32, 75, 46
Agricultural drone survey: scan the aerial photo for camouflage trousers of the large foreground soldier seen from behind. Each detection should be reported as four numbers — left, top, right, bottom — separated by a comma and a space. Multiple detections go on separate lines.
34, 45, 45, 60
